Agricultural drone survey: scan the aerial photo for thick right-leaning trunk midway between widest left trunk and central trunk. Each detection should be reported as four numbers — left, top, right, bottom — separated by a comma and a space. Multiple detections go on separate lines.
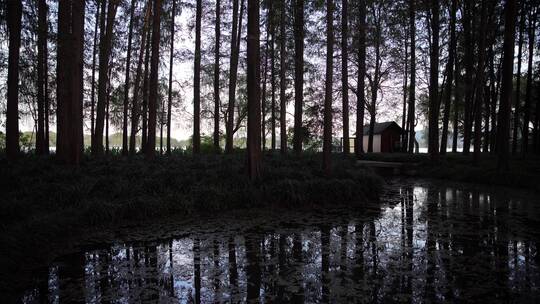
145, 0, 162, 159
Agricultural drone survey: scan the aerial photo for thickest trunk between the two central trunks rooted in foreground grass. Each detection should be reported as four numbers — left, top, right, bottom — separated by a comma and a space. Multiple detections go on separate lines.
293, 0, 304, 154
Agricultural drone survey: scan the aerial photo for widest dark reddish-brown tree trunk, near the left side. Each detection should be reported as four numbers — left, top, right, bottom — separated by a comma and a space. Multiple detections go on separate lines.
56, 0, 85, 165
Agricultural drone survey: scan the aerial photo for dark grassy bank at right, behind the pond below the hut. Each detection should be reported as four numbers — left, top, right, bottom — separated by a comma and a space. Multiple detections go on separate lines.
358, 153, 540, 191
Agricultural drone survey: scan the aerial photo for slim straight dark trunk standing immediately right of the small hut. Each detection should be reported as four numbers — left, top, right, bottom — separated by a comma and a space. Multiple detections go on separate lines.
407, 0, 416, 153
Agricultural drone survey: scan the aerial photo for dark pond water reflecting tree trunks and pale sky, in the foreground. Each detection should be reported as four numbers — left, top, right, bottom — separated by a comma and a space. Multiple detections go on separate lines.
22, 180, 540, 303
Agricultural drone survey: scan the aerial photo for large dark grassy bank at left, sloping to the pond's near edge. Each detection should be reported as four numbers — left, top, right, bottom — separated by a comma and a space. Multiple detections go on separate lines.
0, 154, 382, 296
